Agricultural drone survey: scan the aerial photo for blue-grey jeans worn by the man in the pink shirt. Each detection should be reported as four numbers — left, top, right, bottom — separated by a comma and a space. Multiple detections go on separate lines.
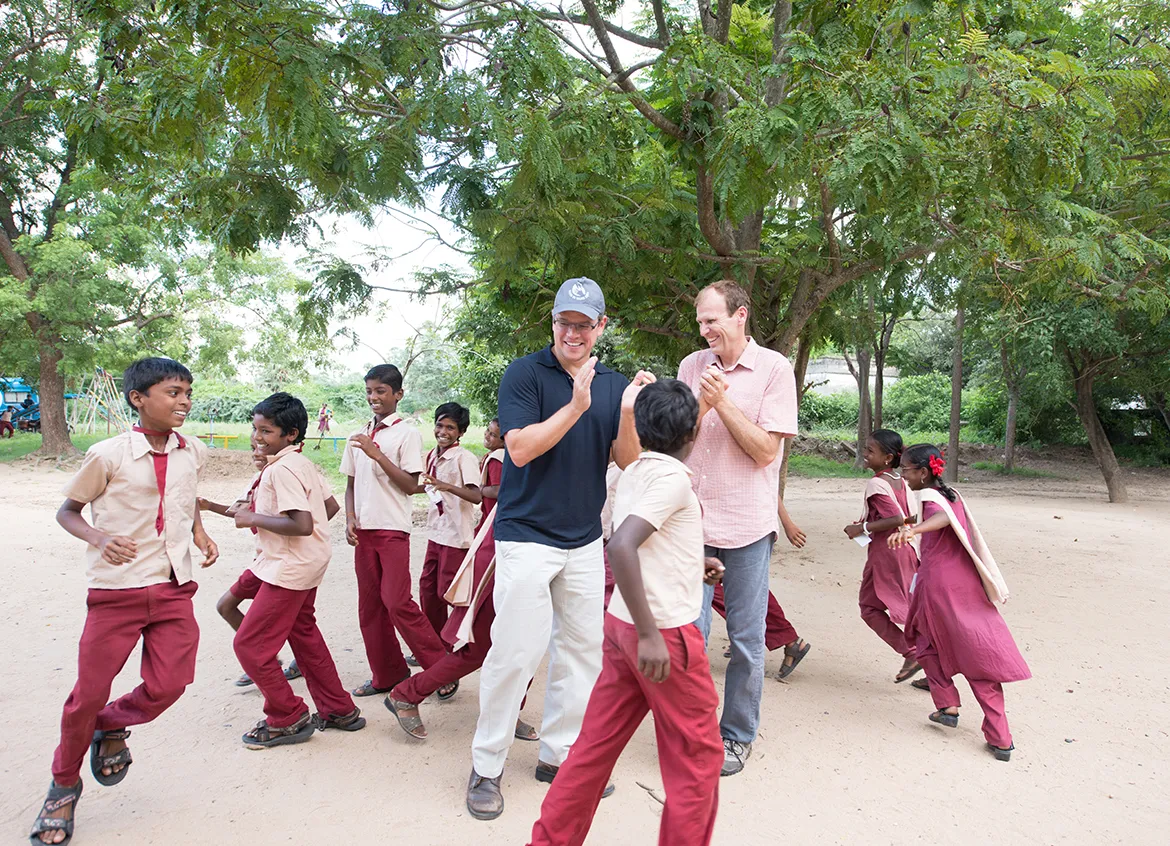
698, 535, 776, 743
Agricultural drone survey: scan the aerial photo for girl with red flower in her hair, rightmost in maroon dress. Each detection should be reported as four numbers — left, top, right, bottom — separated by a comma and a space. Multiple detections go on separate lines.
888, 443, 1032, 761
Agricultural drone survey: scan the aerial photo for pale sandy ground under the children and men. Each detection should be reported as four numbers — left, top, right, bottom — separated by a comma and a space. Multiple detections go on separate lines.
0, 459, 1170, 846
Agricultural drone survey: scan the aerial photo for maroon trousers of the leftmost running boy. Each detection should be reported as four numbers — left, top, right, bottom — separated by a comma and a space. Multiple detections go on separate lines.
53, 582, 199, 786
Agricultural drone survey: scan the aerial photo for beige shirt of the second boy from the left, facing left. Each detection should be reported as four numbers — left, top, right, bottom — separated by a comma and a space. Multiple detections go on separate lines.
252, 445, 332, 591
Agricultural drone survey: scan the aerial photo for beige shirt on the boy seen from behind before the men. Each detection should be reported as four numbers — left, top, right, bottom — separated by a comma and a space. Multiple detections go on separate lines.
610, 452, 703, 628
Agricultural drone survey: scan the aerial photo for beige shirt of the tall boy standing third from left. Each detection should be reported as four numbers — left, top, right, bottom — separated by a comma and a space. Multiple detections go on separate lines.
340, 414, 425, 534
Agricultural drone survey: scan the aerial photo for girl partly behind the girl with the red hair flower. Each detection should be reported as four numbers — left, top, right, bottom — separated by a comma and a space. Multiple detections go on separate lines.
845, 429, 929, 690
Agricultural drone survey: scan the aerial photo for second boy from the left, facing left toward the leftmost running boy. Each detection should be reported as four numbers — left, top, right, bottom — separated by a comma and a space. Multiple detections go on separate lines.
226, 392, 355, 749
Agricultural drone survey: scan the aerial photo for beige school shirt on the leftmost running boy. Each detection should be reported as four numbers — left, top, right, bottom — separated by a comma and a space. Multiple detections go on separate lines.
62, 432, 207, 590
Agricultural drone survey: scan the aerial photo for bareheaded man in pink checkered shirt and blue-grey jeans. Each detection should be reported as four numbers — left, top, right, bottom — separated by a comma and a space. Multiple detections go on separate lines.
679, 280, 797, 776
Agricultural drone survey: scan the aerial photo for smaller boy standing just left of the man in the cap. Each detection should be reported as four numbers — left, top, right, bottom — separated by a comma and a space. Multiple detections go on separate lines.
419, 403, 483, 650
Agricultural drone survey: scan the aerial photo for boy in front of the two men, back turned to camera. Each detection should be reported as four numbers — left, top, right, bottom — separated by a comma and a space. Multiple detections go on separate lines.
531, 379, 723, 846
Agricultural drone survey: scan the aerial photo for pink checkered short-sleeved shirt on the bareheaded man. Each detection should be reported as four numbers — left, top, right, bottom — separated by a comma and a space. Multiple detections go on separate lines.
679, 338, 797, 549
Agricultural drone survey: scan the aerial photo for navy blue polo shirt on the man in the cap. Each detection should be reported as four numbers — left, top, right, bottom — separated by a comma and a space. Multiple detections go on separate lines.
495, 345, 629, 549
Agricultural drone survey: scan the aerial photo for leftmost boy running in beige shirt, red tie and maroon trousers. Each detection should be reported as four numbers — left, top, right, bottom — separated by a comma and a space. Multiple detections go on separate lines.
30, 358, 219, 844
